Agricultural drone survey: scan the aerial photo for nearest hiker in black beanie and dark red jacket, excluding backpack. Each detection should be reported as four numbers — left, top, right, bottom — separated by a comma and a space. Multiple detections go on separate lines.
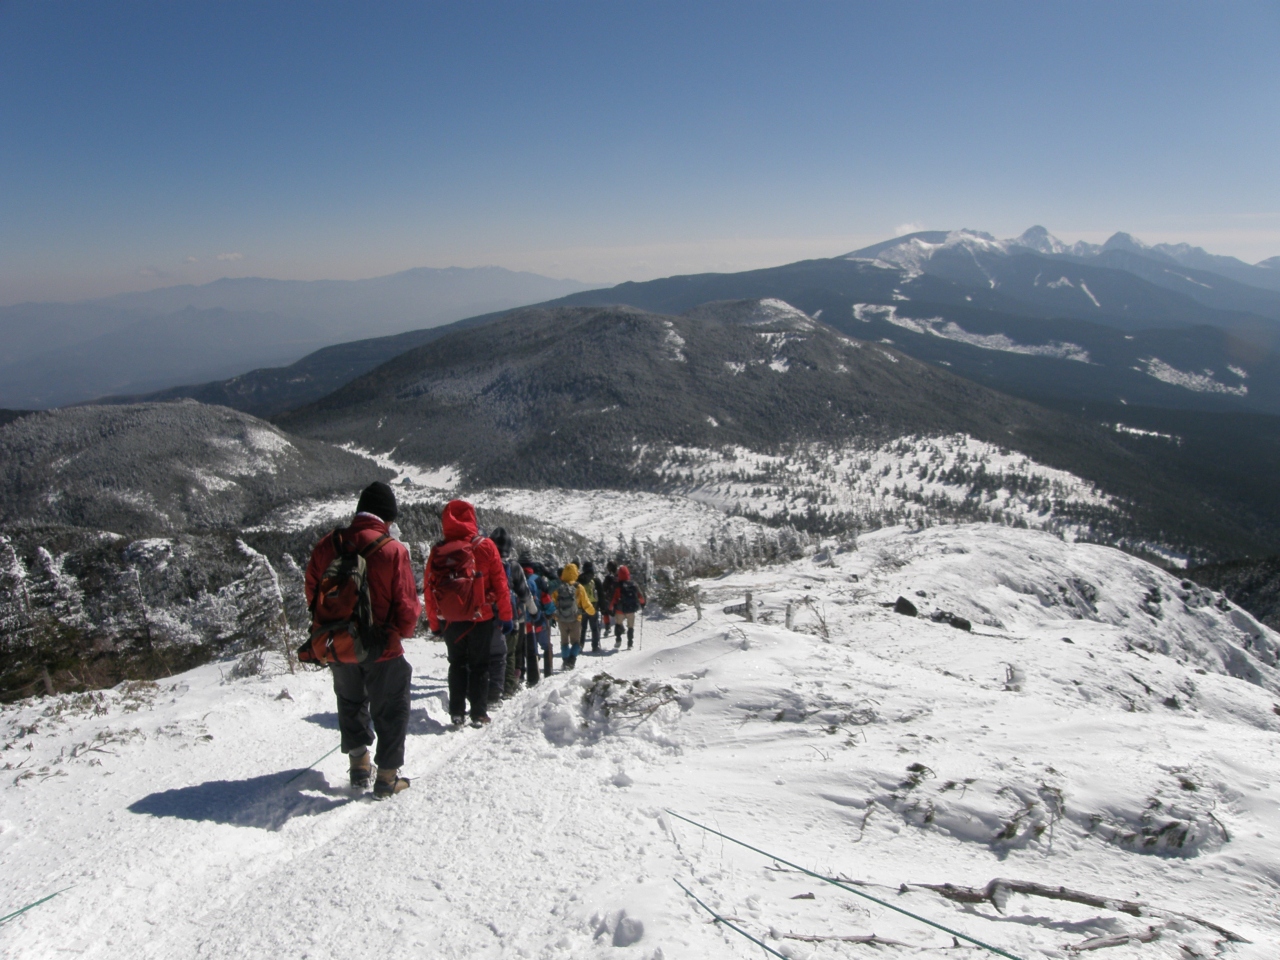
303, 483, 422, 800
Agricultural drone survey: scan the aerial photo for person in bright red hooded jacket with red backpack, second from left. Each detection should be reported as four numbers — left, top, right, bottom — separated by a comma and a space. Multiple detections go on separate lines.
422, 500, 516, 727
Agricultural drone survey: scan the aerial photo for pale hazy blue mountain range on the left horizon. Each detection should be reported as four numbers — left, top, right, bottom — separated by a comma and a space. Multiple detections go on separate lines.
0, 266, 593, 410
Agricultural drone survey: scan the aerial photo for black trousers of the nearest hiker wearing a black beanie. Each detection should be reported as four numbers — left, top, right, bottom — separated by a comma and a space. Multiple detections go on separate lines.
330, 657, 413, 771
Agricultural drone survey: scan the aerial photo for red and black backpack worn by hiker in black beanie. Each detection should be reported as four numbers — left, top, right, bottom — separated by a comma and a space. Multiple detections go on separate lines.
298, 530, 392, 664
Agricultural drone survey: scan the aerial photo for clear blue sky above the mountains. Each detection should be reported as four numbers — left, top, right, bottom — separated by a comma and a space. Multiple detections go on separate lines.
0, 0, 1280, 303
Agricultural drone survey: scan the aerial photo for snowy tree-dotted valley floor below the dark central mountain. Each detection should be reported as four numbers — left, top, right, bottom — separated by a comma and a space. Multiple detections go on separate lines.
257, 434, 1126, 547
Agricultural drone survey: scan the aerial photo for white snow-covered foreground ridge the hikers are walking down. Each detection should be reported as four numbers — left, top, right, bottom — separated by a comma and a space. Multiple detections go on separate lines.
0, 525, 1280, 960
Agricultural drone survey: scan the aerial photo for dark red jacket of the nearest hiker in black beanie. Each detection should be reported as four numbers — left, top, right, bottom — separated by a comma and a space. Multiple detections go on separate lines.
306, 513, 422, 663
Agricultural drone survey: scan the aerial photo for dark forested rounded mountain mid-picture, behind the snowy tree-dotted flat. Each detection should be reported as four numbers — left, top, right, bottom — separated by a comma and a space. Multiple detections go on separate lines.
276, 298, 1280, 550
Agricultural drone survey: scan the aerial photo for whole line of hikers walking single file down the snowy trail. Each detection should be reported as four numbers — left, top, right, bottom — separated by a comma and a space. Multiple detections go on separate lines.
298, 481, 646, 800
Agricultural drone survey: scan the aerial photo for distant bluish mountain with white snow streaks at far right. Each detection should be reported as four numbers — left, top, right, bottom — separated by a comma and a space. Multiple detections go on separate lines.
542, 248, 1280, 412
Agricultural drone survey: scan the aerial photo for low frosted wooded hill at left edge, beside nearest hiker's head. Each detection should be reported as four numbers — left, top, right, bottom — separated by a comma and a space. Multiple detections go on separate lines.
0, 402, 387, 536
